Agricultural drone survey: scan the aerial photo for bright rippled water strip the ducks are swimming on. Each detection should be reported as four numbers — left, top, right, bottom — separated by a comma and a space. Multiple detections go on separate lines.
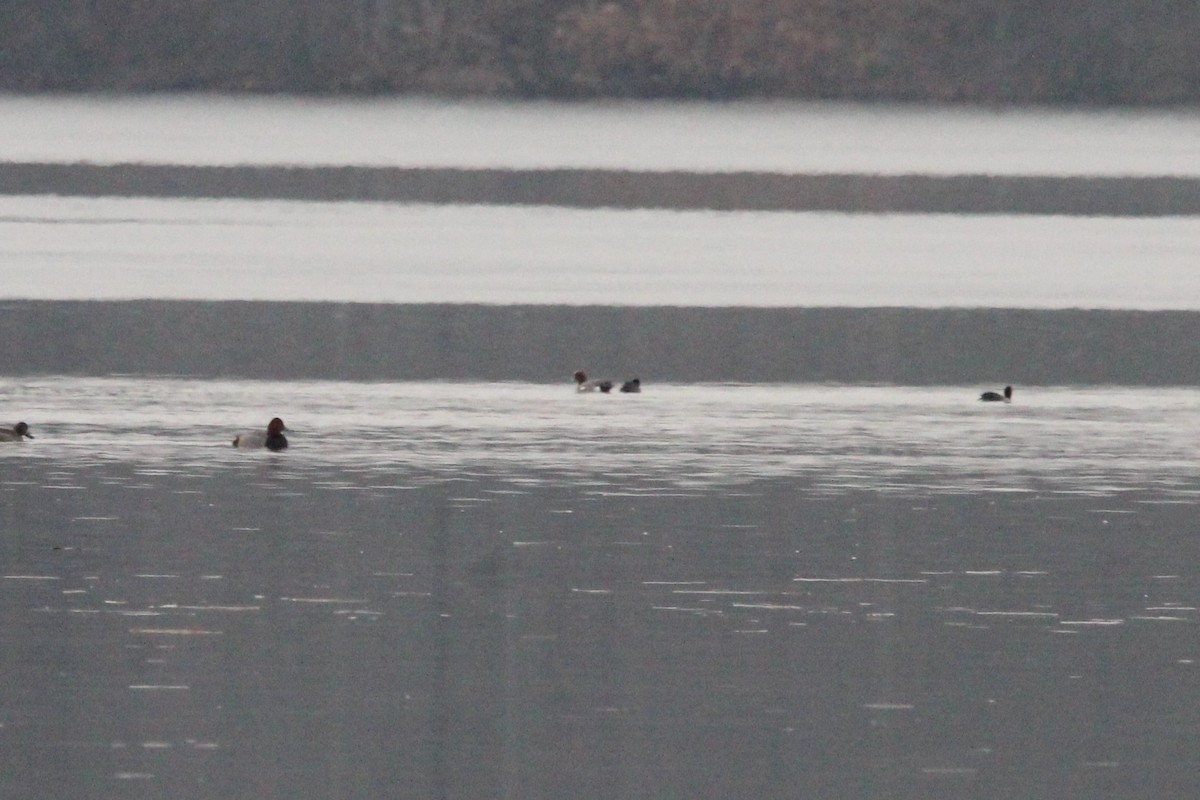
4, 378, 1200, 497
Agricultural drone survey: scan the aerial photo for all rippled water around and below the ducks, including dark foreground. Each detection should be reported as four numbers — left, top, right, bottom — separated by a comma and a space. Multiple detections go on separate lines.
0, 378, 1200, 798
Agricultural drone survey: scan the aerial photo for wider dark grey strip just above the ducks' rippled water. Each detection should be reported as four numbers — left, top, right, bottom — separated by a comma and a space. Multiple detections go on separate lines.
0, 300, 1200, 387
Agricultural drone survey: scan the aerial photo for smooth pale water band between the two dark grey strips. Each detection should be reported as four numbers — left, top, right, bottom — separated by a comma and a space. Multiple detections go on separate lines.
7, 197, 1200, 309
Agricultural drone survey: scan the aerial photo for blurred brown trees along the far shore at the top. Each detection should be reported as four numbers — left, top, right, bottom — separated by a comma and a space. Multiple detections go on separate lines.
0, 0, 1200, 106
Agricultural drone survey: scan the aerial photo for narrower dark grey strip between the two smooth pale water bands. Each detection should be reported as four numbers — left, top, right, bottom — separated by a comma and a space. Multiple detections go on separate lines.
7, 162, 1200, 217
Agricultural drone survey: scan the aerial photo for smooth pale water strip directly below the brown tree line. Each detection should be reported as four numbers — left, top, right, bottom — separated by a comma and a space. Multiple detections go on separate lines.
0, 95, 1200, 175
